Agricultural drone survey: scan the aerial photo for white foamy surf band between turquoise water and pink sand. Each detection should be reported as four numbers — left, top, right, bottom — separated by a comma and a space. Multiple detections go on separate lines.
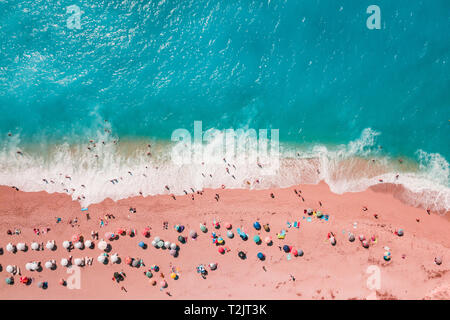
0, 129, 450, 211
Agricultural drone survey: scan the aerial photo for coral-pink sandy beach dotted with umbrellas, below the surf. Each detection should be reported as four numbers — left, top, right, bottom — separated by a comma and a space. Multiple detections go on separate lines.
0, 183, 450, 299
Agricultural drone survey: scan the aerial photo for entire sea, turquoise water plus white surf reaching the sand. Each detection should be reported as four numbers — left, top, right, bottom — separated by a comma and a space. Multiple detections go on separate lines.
0, 0, 450, 211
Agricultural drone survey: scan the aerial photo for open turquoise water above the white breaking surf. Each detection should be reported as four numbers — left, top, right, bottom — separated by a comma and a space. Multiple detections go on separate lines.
0, 0, 450, 160
